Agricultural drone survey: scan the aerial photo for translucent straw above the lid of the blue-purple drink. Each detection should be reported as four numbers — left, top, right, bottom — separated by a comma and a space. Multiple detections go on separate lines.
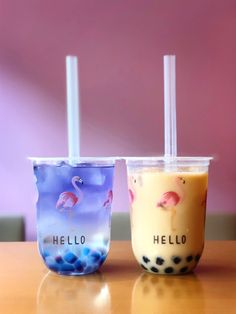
66, 56, 80, 159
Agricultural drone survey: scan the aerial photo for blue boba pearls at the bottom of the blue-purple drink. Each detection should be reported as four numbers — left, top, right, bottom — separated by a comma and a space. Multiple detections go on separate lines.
42, 247, 107, 275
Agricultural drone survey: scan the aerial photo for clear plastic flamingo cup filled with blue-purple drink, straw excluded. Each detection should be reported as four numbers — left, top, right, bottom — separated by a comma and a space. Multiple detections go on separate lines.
31, 158, 114, 275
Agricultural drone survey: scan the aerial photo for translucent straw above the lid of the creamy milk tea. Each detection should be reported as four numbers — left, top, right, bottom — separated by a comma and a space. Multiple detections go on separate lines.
164, 55, 177, 157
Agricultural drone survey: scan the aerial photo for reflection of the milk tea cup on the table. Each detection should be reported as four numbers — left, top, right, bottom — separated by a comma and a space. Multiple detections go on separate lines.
132, 273, 204, 314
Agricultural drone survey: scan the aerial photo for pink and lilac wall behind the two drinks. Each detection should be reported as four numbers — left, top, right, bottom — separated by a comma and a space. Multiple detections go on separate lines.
0, 0, 236, 239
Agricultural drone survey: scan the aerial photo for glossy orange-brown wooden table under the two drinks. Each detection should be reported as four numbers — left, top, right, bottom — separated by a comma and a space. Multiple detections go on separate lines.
0, 241, 236, 314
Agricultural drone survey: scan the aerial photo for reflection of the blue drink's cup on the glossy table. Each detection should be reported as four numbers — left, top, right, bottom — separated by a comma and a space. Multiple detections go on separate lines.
37, 272, 111, 314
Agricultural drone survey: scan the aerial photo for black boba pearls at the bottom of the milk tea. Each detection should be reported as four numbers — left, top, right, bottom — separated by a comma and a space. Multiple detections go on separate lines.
141, 254, 201, 275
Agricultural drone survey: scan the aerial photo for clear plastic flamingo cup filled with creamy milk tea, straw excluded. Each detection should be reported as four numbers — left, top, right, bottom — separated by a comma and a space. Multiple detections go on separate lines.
127, 157, 211, 275
